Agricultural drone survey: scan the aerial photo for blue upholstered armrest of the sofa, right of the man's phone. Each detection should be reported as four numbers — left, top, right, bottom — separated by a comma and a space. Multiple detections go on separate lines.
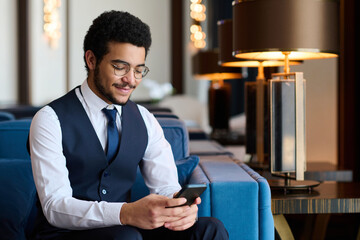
200, 155, 274, 239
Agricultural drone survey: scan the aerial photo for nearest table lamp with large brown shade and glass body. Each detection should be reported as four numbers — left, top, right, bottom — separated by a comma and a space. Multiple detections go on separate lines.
233, 0, 339, 189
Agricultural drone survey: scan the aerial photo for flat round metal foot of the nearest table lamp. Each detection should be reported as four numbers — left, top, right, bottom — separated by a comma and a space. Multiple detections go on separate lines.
268, 178, 320, 194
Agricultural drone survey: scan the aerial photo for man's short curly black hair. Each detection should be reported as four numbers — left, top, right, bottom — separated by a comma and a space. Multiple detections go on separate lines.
84, 10, 151, 72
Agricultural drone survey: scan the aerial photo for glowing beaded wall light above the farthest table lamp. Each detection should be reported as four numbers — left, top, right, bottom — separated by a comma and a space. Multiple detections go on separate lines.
190, 0, 206, 49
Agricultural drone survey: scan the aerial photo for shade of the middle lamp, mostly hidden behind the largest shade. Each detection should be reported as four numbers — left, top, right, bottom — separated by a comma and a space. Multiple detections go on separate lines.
217, 19, 302, 67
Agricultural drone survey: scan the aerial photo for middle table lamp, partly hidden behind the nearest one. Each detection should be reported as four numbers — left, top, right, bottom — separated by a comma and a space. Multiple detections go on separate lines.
218, 19, 302, 168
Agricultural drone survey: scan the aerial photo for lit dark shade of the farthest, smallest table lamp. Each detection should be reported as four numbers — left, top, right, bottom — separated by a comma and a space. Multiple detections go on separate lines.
192, 49, 242, 80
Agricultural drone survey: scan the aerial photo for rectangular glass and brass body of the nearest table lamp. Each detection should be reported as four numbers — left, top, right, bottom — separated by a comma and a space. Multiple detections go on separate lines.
269, 72, 306, 179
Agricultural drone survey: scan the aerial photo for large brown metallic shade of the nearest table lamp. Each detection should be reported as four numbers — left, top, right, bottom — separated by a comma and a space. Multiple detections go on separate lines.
233, 0, 339, 60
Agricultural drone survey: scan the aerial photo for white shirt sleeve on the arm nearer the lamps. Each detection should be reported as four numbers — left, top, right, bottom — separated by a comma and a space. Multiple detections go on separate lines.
139, 106, 181, 198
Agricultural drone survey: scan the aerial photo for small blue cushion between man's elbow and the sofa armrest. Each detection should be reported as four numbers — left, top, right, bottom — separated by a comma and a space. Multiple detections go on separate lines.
175, 155, 200, 186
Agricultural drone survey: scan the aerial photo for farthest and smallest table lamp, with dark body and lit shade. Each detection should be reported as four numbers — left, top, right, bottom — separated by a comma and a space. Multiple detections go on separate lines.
192, 49, 242, 141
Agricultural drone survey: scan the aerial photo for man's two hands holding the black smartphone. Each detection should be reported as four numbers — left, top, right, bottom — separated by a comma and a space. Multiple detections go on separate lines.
120, 194, 201, 230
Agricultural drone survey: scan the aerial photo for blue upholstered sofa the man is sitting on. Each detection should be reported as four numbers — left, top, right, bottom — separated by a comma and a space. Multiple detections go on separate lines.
0, 117, 274, 240
